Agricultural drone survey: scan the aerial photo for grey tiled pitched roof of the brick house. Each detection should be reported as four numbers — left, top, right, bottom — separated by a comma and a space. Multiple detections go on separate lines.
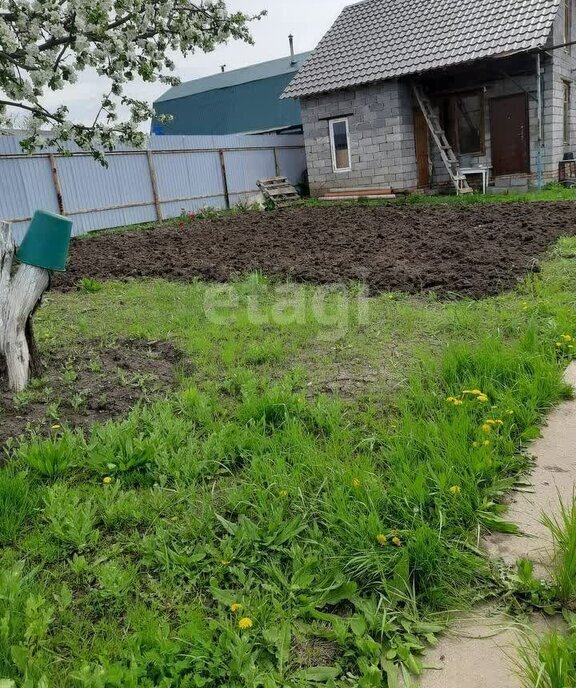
282, 0, 560, 98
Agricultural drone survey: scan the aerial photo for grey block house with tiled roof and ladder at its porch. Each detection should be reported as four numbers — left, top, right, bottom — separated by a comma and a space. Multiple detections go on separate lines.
282, 0, 576, 195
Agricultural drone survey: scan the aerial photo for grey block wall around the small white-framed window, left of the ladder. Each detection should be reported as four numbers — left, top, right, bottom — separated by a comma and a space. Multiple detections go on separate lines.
301, 81, 416, 195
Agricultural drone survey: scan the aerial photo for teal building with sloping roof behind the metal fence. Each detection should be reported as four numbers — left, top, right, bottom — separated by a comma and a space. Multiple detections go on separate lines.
152, 41, 310, 135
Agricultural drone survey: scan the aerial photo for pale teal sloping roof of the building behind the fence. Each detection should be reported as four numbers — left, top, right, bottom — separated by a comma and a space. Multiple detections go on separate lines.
156, 53, 311, 103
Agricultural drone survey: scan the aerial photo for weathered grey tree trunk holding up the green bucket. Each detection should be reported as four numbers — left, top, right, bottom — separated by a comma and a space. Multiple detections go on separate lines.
0, 222, 50, 392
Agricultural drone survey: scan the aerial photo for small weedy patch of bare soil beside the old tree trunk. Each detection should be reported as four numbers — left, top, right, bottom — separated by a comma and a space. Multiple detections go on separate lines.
0, 340, 182, 443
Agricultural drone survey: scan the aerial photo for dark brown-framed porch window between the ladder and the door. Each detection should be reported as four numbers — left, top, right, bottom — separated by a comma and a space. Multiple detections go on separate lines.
442, 92, 484, 154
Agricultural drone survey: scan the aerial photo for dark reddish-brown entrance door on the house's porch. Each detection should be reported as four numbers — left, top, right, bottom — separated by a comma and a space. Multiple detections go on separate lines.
490, 93, 530, 176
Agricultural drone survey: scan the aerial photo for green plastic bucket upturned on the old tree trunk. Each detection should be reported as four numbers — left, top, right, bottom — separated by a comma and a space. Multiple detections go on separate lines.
16, 210, 72, 272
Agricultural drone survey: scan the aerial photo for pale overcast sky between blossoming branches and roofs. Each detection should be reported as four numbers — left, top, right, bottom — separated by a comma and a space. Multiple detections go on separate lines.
37, 0, 353, 130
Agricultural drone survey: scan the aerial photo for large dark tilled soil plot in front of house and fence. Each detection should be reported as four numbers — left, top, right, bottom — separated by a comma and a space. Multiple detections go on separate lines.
54, 202, 576, 297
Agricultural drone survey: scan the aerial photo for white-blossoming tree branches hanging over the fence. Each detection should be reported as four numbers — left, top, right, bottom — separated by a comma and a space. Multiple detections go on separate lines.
0, 0, 265, 161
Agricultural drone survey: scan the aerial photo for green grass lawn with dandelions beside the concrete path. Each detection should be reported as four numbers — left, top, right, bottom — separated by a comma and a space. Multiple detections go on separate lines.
0, 234, 576, 688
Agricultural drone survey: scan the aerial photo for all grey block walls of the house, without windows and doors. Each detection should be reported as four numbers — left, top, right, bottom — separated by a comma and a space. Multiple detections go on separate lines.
301, 0, 576, 195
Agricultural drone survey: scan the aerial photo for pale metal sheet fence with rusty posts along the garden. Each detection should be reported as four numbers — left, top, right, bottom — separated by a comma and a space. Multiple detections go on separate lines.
0, 135, 306, 242
